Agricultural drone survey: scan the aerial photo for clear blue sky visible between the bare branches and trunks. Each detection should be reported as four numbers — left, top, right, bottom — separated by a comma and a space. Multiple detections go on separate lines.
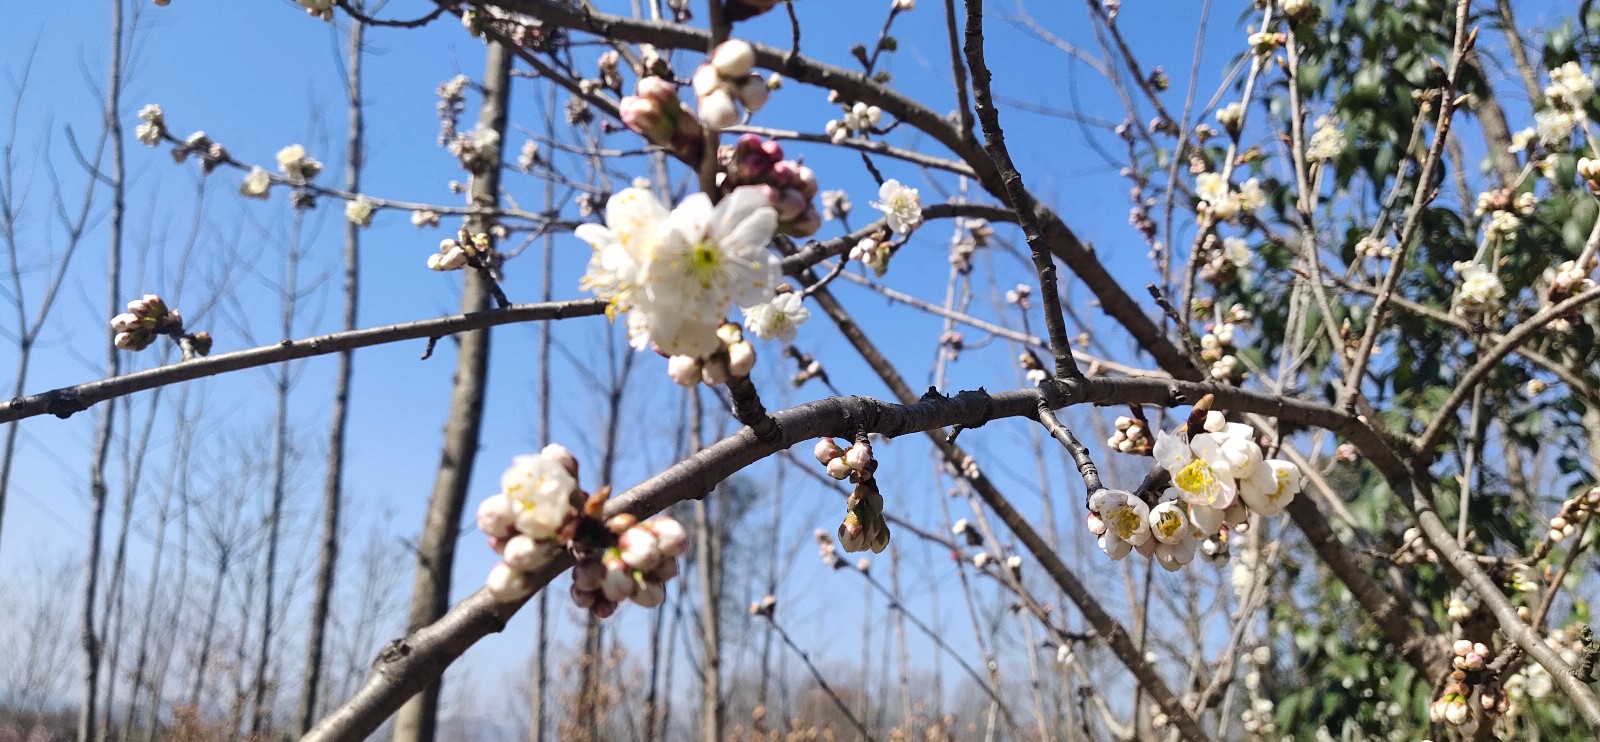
0, 0, 1574, 729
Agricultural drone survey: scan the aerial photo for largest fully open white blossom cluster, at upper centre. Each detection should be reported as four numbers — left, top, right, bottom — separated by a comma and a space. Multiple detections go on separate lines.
576, 186, 781, 358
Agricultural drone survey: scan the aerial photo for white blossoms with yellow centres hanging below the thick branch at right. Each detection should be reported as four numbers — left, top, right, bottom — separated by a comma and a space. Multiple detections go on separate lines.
1088, 409, 1301, 571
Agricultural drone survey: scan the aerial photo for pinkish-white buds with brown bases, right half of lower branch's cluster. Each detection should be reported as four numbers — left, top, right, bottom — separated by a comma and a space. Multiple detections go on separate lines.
571, 515, 690, 619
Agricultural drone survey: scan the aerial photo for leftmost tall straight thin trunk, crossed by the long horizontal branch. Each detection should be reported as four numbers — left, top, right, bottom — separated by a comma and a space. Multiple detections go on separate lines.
77, 0, 126, 742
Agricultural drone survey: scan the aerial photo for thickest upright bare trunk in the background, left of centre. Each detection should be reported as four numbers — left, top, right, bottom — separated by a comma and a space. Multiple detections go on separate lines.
394, 42, 512, 742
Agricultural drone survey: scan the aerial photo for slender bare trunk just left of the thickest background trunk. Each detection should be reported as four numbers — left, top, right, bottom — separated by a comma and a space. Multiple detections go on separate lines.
294, 12, 366, 734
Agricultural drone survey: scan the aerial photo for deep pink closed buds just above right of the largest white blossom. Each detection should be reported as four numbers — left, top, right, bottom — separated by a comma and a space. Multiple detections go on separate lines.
717, 134, 822, 237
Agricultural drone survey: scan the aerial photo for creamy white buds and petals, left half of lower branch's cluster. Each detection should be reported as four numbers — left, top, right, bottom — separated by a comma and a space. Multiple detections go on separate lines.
478, 445, 586, 601
